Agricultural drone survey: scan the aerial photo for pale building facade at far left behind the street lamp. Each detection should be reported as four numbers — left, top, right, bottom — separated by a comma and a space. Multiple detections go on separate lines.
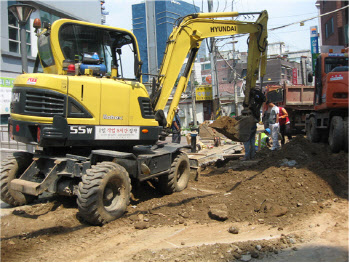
0, 0, 104, 119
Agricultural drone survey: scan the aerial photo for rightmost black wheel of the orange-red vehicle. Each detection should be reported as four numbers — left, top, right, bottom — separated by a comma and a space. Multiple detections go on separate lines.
328, 116, 344, 153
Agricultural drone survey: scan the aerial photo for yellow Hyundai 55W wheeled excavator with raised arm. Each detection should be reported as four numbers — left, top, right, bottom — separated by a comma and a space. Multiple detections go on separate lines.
0, 11, 268, 225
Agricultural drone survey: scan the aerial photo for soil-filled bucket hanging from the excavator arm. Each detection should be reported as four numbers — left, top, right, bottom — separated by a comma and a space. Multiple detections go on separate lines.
209, 116, 257, 142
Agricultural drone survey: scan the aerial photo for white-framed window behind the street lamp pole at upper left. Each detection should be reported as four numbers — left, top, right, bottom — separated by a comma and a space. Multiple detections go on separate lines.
8, 11, 32, 55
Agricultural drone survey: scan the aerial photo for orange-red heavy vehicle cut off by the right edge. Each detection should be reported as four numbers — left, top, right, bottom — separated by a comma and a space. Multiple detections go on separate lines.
306, 49, 349, 153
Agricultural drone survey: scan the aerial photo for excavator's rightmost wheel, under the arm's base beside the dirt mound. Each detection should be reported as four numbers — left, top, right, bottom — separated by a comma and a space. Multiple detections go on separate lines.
159, 153, 190, 194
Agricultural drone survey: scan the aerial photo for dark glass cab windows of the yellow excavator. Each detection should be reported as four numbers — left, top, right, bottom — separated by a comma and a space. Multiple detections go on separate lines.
59, 23, 138, 79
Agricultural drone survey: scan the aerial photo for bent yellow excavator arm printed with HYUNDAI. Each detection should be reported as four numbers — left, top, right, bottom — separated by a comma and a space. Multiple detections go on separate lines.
151, 11, 268, 135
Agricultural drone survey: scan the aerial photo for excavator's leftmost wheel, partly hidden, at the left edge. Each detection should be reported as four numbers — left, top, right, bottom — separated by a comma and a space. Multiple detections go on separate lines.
0, 152, 36, 206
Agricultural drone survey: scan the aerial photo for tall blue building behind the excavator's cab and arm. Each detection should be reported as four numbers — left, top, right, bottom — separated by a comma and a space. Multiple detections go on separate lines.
132, 0, 205, 81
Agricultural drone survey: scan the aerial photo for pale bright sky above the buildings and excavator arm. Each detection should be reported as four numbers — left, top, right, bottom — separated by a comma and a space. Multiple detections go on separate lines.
105, 0, 318, 52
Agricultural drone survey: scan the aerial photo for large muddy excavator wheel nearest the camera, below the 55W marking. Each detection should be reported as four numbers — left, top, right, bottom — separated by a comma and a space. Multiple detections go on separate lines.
77, 162, 131, 225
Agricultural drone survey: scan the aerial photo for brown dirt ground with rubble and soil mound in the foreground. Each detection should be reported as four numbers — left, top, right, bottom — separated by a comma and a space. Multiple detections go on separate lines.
1, 136, 349, 262
